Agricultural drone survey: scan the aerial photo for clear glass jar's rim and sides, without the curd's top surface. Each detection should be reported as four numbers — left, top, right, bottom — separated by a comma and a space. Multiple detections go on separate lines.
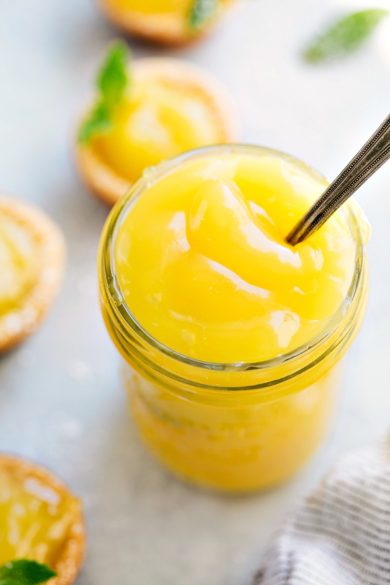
99, 145, 367, 492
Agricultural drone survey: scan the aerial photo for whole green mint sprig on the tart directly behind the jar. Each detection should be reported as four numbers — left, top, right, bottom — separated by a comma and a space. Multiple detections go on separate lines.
78, 42, 130, 144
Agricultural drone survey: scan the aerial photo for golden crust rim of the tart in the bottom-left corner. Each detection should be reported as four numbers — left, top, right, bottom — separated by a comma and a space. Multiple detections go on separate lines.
0, 453, 85, 585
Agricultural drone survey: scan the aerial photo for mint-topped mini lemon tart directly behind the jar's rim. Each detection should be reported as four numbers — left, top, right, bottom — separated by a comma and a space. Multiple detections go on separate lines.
77, 42, 235, 203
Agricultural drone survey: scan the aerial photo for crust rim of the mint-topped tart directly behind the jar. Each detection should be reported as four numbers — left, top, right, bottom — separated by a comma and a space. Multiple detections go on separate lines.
76, 58, 237, 205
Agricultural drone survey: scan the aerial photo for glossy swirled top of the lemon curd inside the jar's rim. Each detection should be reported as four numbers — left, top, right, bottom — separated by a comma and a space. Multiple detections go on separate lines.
115, 150, 364, 363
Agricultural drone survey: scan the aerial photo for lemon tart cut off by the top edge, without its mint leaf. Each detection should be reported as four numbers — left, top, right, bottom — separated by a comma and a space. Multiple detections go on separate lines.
100, 0, 233, 46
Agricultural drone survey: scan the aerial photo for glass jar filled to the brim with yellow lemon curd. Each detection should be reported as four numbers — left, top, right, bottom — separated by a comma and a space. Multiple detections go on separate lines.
101, 146, 366, 491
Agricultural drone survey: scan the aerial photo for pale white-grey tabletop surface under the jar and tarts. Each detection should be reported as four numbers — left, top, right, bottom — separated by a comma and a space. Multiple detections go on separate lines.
0, 0, 390, 585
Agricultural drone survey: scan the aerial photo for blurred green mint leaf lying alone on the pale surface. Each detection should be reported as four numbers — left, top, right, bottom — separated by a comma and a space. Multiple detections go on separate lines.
303, 9, 389, 63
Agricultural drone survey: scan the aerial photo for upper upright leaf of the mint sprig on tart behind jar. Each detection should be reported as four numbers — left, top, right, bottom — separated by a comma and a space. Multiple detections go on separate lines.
97, 43, 129, 107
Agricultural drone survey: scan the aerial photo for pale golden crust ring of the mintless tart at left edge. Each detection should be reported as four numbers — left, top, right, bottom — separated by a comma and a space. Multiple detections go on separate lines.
0, 196, 65, 353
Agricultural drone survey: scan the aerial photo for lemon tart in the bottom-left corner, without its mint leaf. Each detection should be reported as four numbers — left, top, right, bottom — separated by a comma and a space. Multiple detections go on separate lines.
0, 456, 82, 564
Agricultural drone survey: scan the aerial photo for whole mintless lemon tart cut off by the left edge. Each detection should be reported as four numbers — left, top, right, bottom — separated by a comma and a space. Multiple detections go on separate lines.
0, 196, 65, 352
